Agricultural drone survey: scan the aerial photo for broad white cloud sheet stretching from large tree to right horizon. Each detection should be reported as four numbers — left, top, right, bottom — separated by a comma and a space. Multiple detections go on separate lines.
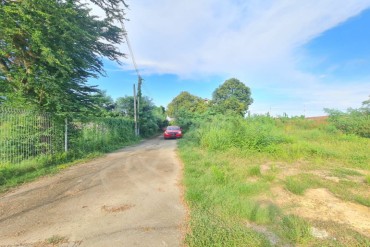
87, 0, 370, 114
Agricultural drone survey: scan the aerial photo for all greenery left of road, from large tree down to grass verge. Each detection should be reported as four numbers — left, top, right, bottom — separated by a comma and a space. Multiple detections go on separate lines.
0, 0, 167, 190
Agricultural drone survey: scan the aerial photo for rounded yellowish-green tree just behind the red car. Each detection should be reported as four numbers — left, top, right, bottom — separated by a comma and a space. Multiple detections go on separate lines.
167, 92, 208, 118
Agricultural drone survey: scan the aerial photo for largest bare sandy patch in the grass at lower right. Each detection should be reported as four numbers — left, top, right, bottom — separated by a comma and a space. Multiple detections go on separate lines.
273, 187, 370, 237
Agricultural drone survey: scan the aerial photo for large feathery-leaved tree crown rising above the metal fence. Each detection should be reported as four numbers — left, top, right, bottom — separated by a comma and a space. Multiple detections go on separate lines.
0, 0, 124, 111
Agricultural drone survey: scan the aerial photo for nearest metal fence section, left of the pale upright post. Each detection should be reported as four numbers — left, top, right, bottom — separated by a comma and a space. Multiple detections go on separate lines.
0, 108, 63, 164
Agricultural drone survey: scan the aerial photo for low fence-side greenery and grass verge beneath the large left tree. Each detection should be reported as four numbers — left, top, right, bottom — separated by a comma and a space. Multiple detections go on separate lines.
0, 100, 167, 192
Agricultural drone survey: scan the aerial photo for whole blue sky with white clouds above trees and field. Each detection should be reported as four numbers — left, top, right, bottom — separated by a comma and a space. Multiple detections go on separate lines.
89, 0, 370, 116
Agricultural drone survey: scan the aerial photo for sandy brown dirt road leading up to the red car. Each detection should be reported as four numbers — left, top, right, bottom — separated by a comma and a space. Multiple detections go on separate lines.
0, 137, 185, 247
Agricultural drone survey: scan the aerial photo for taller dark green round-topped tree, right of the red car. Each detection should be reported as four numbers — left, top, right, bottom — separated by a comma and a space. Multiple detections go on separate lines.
212, 78, 253, 116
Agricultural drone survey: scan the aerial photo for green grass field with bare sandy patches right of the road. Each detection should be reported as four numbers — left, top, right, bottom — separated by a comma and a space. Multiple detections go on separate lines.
179, 117, 370, 247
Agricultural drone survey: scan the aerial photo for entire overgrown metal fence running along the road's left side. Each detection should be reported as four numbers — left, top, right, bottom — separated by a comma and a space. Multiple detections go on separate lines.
0, 108, 135, 165
